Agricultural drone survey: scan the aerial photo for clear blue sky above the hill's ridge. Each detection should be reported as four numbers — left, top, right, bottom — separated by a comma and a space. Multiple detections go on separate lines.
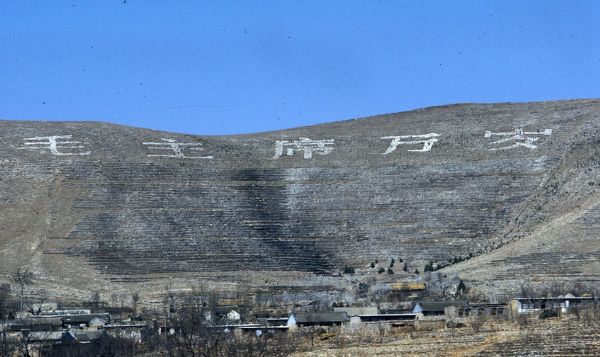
0, 0, 600, 134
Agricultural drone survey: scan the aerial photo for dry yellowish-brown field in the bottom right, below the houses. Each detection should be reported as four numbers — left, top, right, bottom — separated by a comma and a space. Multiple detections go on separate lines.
294, 316, 600, 357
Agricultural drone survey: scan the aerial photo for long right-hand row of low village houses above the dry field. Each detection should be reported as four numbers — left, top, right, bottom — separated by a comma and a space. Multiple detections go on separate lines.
206, 294, 598, 336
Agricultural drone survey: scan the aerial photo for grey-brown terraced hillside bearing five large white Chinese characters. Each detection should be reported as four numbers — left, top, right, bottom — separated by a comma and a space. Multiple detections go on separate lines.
0, 100, 600, 295
